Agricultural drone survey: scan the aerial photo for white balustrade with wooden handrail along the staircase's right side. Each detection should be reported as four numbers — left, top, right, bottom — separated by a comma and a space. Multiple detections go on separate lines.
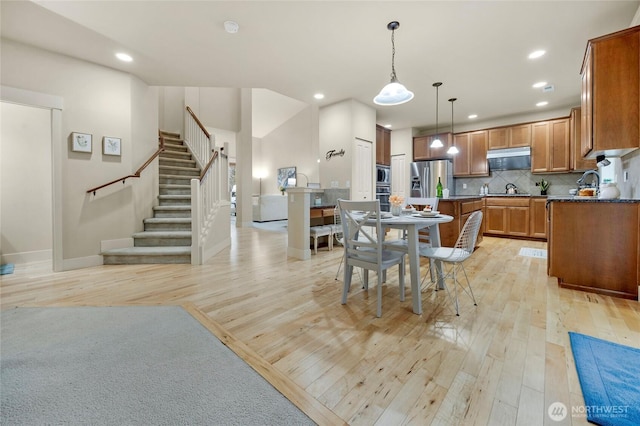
185, 107, 229, 265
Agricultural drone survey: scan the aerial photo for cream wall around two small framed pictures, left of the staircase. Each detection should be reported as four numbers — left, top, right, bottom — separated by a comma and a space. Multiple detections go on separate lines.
0, 39, 158, 269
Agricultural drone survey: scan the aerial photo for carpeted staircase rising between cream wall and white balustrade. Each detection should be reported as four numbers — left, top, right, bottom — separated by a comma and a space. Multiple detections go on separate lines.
102, 132, 200, 265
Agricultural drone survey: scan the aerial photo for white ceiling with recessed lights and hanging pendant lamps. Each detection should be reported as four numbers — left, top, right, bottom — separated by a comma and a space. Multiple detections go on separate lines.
0, 0, 640, 131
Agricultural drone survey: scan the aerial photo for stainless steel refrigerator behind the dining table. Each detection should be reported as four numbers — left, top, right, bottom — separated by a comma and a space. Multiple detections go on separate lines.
409, 160, 455, 198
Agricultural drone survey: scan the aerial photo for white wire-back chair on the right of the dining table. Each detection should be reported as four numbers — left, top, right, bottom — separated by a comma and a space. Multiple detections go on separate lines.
420, 211, 482, 316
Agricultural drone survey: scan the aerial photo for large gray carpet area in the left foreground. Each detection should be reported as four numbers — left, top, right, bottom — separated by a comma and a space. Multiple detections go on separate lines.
0, 306, 315, 425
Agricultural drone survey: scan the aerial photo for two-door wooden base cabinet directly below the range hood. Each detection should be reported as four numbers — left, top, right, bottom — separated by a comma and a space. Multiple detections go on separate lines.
484, 197, 531, 237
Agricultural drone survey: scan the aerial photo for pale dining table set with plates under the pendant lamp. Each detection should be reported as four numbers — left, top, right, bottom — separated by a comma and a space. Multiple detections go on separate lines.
371, 213, 453, 315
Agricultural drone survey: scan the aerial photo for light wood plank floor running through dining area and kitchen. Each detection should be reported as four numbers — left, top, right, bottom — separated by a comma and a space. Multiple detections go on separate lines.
0, 228, 640, 425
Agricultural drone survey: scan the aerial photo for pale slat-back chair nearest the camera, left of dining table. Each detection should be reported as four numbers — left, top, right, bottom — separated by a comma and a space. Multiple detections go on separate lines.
338, 200, 405, 317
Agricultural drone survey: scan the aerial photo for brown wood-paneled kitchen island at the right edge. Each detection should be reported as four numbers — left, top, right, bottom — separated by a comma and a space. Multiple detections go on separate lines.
547, 197, 640, 300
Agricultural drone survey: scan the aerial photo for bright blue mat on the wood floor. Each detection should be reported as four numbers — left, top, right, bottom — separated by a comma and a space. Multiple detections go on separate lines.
569, 331, 640, 426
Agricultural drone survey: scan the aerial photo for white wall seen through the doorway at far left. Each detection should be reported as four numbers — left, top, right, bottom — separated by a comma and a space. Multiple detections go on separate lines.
0, 102, 53, 263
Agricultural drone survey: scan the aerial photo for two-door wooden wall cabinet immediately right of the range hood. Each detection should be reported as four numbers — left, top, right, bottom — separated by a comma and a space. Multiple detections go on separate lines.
531, 118, 571, 173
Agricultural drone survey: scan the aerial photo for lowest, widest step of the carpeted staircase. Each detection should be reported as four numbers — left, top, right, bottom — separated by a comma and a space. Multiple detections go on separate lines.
102, 246, 191, 265
